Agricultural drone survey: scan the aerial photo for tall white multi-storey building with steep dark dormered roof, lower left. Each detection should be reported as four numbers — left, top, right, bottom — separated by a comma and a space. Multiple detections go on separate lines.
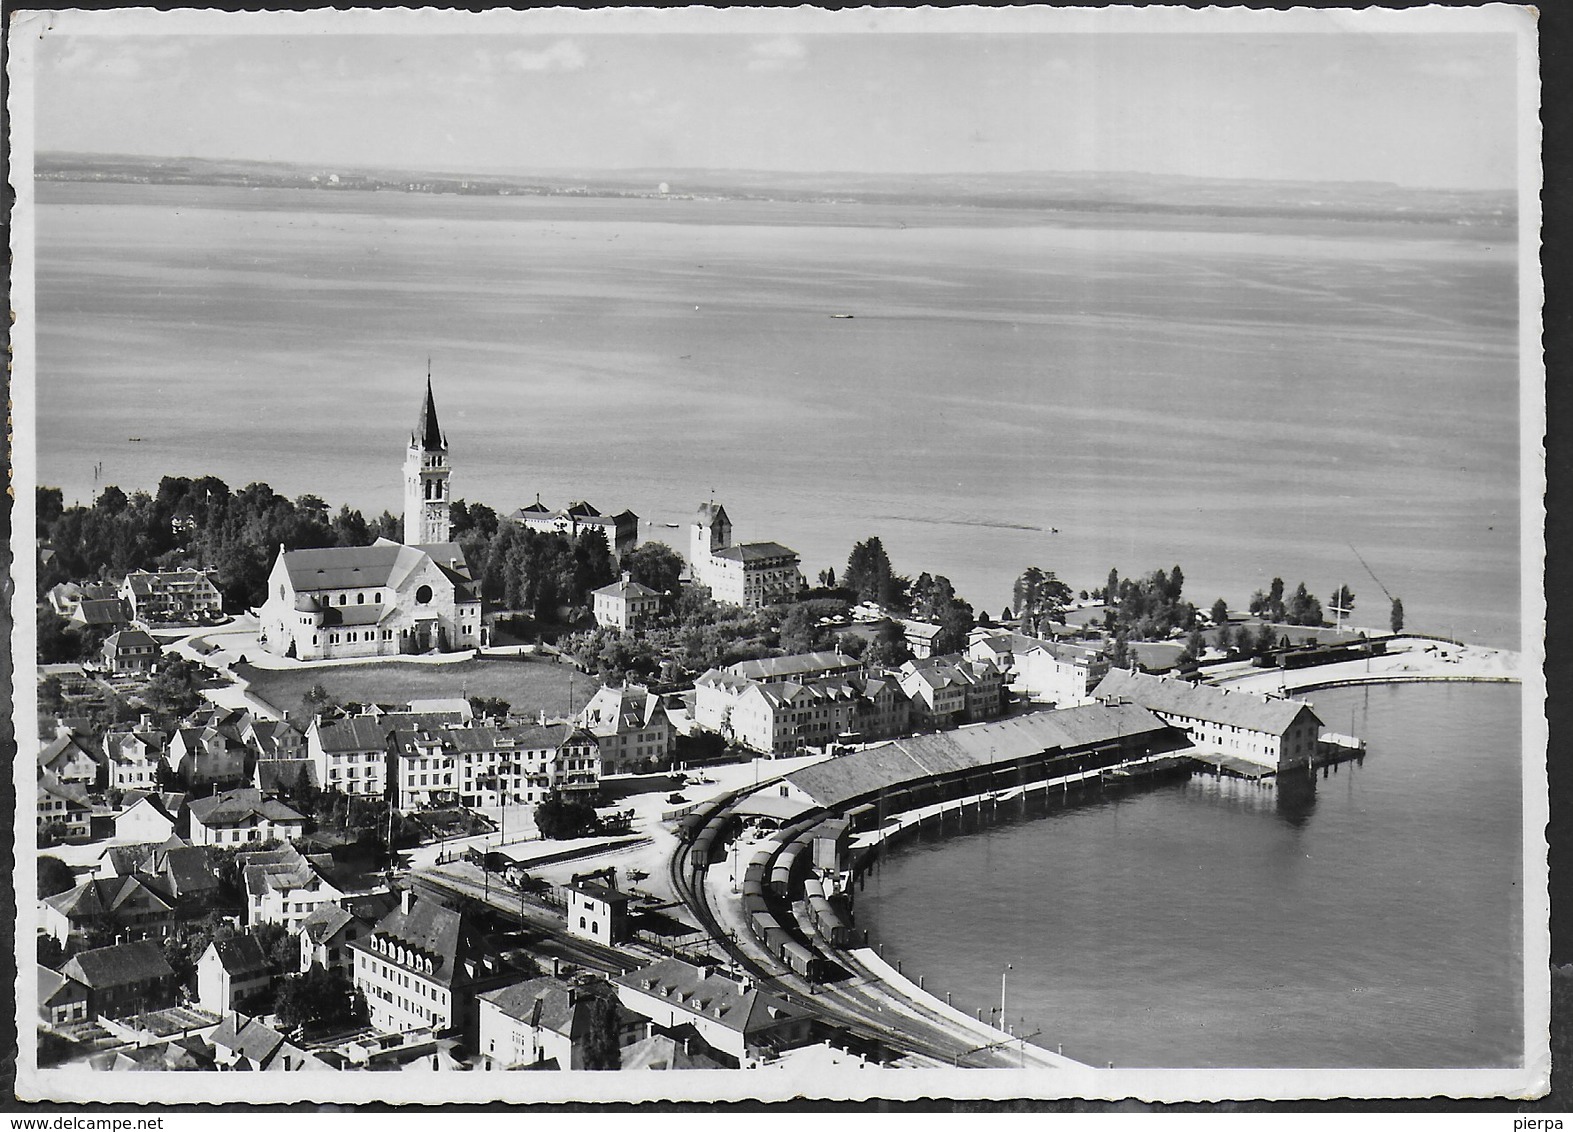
346, 890, 518, 1036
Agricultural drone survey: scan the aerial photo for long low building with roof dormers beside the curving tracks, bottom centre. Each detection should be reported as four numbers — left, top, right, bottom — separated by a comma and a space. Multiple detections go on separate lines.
612, 959, 813, 1064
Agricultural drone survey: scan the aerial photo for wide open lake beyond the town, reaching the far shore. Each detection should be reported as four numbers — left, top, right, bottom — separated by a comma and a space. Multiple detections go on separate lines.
27, 182, 1520, 646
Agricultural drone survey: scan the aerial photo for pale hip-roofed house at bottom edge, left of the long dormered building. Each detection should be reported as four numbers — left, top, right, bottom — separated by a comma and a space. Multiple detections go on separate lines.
478, 976, 645, 1069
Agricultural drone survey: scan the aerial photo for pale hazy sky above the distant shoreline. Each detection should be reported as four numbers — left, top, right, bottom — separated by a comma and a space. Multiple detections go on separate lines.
21, 13, 1518, 189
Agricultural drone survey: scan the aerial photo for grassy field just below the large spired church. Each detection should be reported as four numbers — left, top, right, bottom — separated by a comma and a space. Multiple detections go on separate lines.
236, 657, 596, 715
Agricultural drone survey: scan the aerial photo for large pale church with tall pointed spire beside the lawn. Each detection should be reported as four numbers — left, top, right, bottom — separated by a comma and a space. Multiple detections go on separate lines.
258, 376, 484, 660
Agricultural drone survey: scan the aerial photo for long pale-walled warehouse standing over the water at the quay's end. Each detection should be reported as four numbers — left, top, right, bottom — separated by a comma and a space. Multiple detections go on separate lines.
1093, 668, 1321, 770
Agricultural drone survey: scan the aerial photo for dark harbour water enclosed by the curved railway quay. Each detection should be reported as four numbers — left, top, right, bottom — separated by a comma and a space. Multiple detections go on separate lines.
856, 685, 1524, 1068
